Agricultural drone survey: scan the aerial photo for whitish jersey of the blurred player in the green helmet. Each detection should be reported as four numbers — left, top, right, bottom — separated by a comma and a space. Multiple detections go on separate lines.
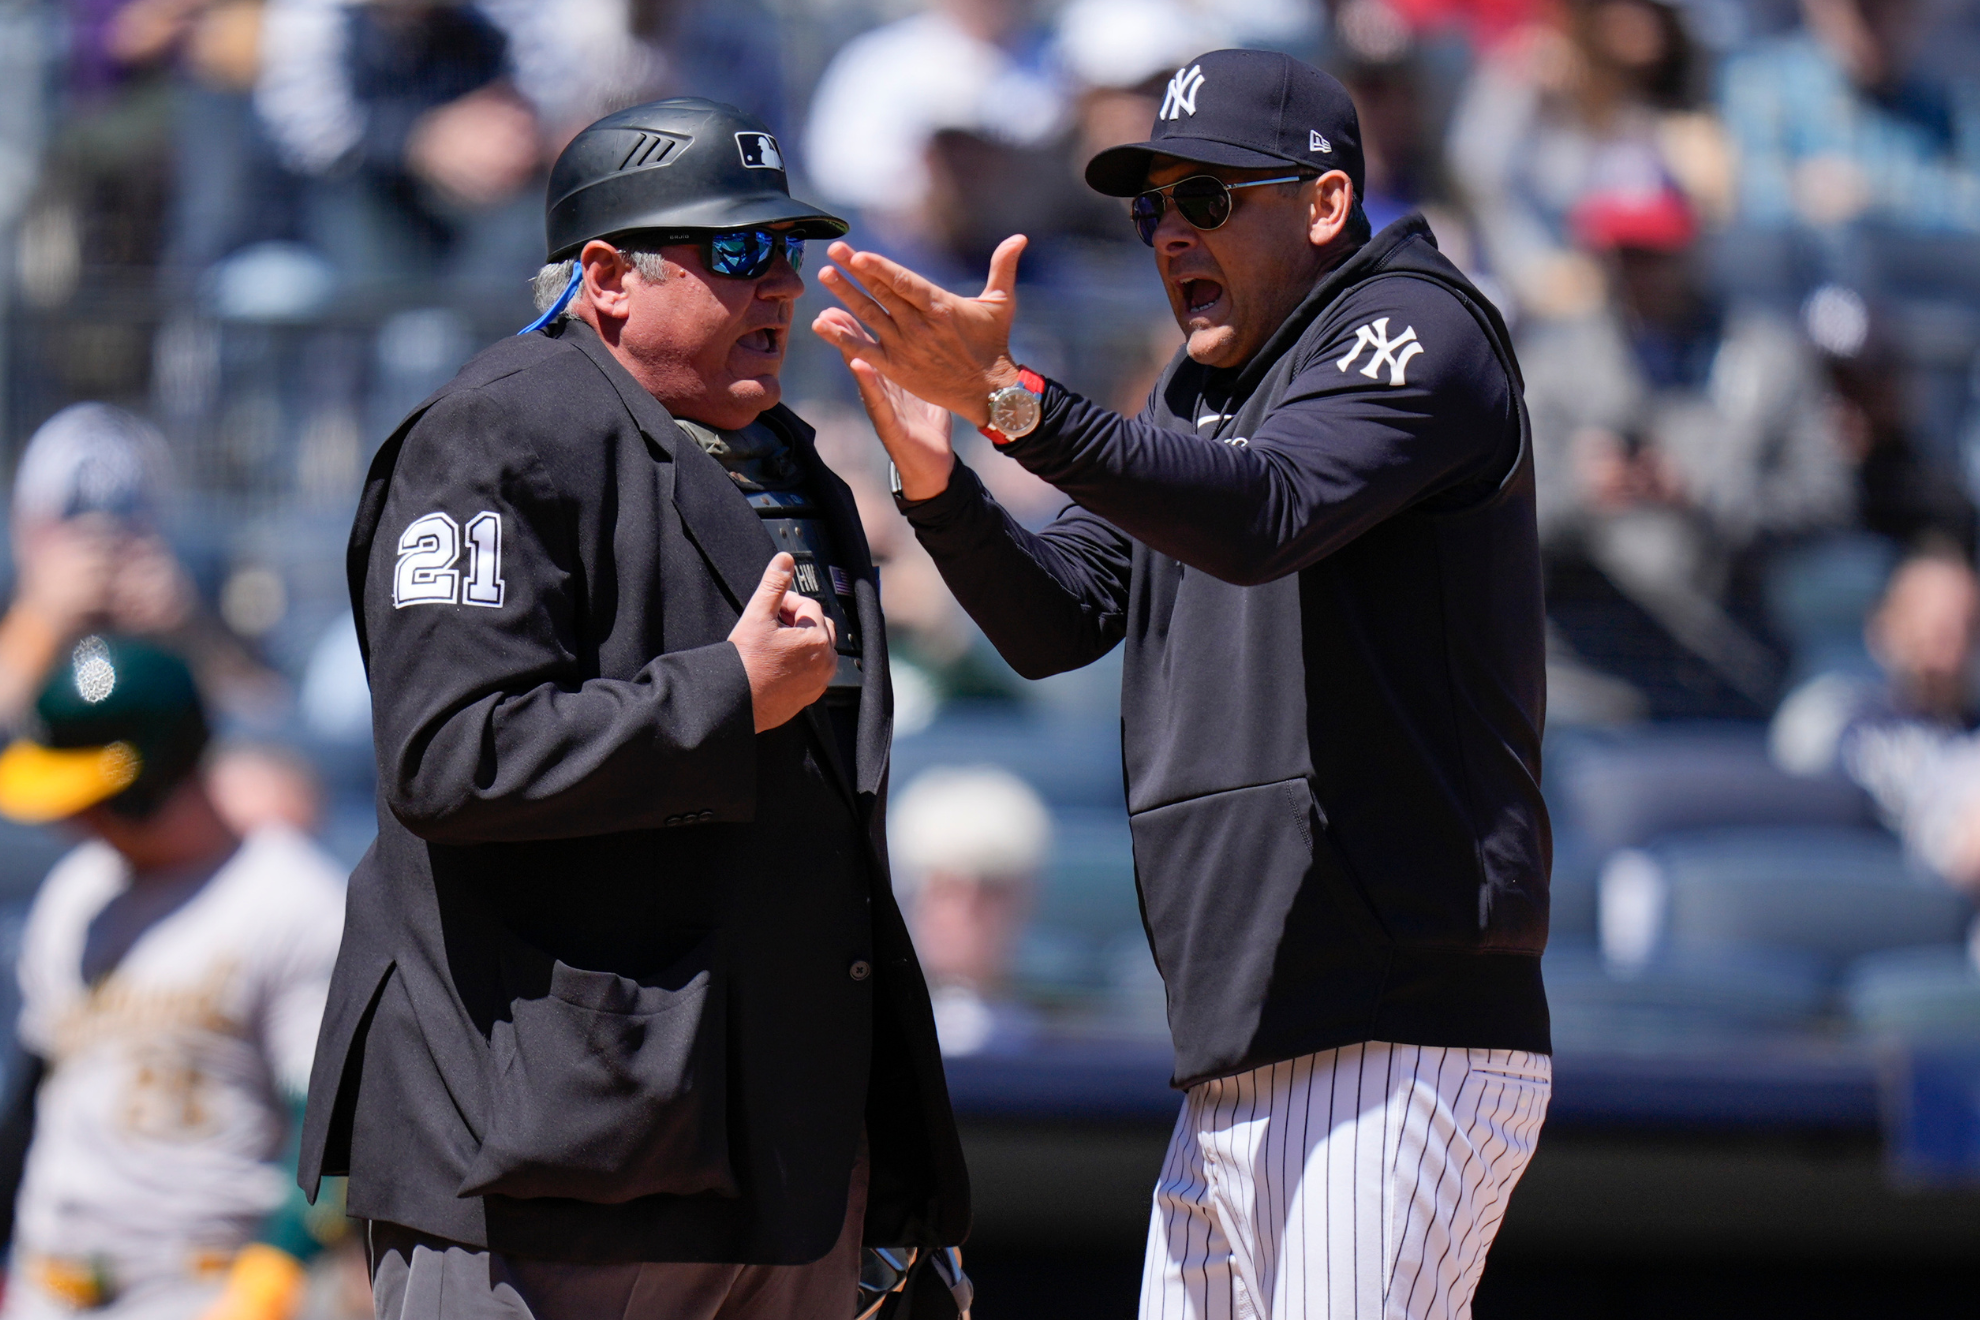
14, 827, 345, 1280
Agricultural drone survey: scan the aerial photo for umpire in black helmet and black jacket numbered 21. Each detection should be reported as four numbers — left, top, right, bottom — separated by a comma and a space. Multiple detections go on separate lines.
301, 99, 968, 1320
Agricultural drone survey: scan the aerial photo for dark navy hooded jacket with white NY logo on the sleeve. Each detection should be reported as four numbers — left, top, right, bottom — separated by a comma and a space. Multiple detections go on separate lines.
903, 218, 1550, 1086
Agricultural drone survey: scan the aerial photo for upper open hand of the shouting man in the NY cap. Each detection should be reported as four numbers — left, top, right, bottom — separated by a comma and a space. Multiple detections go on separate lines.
812, 234, 1026, 425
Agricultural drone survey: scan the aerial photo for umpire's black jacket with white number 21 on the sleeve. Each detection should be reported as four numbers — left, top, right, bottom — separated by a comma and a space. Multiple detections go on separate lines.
301, 321, 968, 1266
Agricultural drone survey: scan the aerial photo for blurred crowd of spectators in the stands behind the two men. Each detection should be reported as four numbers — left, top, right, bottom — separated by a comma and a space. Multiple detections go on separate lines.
0, 0, 1980, 1314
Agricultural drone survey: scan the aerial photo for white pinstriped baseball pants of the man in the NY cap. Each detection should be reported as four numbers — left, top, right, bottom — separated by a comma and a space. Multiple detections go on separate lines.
1140, 1041, 1552, 1320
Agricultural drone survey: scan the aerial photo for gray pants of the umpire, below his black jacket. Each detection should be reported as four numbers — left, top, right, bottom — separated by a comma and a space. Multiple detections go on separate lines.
366, 1160, 867, 1320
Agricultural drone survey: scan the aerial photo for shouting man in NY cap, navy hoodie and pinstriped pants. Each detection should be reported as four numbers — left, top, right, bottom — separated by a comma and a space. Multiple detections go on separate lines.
814, 49, 1550, 1320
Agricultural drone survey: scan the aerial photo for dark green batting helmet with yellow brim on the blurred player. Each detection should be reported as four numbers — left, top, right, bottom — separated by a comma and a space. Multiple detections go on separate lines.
0, 635, 206, 825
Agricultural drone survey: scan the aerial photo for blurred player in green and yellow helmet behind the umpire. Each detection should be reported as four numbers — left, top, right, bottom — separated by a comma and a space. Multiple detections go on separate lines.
0, 637, 343, 1320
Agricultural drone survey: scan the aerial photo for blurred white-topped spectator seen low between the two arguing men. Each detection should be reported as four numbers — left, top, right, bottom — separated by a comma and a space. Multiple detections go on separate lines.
891, 766, 1051, 1055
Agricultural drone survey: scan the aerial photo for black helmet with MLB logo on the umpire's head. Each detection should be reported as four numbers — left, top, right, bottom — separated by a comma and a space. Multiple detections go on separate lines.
545, 97, 851, 261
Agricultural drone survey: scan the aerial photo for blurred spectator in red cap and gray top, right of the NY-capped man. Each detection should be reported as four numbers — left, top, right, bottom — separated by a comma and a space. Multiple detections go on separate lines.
1521, 186, 1851, 714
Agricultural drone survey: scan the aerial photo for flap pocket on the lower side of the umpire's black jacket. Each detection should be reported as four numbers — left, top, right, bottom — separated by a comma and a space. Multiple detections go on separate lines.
459, 936, 739, 1205
